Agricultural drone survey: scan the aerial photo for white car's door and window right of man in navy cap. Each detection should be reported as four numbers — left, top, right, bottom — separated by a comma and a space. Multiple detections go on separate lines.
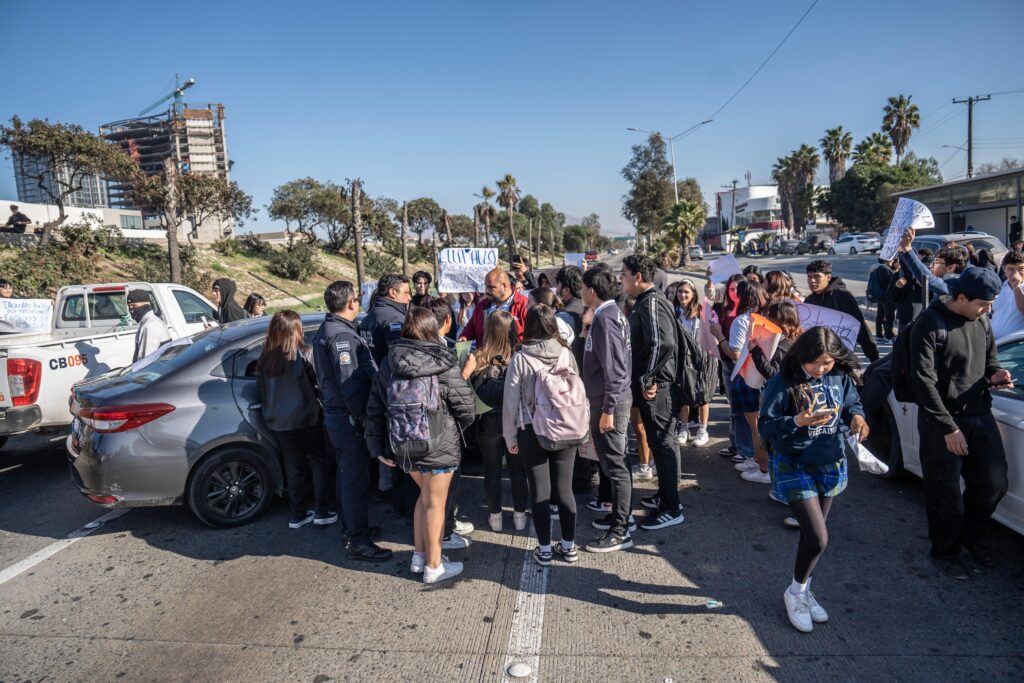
992, 338, 1024, 533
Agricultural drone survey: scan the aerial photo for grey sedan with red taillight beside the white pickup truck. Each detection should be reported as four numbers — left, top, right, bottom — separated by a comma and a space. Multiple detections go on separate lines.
67, 313, 324, 526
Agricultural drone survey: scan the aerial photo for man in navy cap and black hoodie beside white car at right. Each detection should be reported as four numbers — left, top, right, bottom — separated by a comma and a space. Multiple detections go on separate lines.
910, 267, 1013, 581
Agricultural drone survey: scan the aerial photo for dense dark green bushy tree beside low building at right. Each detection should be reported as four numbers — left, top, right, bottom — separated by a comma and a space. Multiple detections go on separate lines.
818, 152, 942, 229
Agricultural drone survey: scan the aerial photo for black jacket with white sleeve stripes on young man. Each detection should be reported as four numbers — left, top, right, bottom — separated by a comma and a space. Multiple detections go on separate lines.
630, 287, 679, 398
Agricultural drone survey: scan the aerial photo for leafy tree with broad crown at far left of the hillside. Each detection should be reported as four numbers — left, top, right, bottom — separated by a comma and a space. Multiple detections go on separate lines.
0, 116, 138, 247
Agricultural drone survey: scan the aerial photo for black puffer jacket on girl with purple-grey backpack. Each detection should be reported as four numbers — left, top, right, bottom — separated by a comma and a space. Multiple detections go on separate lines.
367, 339, 475, 468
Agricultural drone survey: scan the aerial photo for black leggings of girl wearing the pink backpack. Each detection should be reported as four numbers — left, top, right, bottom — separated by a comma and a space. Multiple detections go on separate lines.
520, 425, 577, 546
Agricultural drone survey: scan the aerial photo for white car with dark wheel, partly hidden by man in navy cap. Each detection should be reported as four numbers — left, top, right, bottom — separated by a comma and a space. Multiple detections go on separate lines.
861, 331, 1024, 533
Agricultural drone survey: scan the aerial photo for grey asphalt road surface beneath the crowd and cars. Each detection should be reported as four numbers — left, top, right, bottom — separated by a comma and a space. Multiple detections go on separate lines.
0, 257, 1024, 683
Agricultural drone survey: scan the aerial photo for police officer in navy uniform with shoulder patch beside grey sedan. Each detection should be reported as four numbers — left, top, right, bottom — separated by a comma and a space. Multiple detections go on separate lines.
313, 281, 391, 562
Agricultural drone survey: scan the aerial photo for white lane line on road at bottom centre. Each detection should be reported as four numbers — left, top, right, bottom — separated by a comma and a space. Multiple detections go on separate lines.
502, 523, 558, 683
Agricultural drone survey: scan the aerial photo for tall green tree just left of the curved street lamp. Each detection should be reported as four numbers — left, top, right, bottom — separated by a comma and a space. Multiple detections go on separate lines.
622, 133, 674, 250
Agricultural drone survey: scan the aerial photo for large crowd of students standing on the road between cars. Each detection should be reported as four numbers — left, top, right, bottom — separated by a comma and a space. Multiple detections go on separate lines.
243, 245, 1024, 632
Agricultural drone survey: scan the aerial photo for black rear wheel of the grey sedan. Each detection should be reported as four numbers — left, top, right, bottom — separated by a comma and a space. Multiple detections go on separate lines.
187, 449, 273, 526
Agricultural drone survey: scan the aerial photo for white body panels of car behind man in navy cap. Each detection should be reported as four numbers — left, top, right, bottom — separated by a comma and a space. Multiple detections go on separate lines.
872, 330, 1024, 535
